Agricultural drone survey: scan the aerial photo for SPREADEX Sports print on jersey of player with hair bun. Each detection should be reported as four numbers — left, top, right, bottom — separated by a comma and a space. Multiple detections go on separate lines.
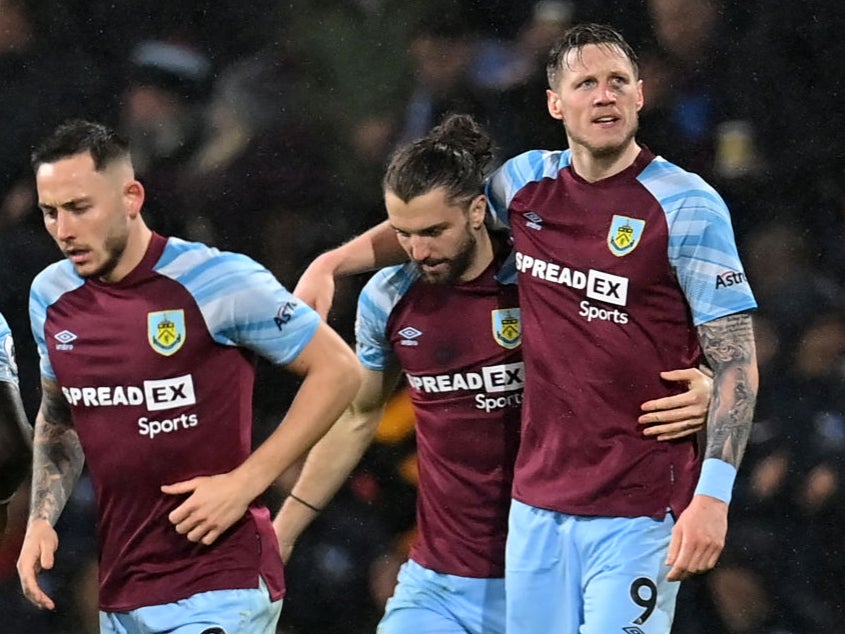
407, 361, 525, 412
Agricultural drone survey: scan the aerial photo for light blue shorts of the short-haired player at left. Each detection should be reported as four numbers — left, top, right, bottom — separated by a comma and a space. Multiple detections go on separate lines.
100, 579, 282, 634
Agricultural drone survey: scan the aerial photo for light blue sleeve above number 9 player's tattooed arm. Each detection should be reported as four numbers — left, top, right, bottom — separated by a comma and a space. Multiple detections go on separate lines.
639, 157, 757, 326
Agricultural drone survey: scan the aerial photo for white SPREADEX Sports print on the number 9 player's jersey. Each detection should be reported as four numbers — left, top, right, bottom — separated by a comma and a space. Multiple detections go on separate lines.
516, 251, 628, 324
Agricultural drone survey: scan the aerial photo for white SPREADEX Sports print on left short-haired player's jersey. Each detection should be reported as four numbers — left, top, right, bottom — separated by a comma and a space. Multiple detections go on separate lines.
62, 374, 199, 438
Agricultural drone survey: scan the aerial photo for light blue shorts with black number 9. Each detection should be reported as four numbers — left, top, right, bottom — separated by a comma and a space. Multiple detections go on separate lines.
505, 500, 680, 634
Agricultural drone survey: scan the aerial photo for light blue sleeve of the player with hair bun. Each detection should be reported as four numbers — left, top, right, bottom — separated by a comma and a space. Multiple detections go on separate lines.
355, 263, 419, 372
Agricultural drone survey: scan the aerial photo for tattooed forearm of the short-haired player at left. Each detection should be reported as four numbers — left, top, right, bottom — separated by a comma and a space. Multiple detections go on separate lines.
30, 384, 84, 525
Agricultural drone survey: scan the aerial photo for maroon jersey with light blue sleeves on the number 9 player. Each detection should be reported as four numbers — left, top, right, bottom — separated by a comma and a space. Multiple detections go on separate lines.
487, 148, 756, 517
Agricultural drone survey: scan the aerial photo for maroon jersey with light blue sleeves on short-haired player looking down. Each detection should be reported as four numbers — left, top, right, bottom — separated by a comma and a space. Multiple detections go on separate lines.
30, 234, 319, 611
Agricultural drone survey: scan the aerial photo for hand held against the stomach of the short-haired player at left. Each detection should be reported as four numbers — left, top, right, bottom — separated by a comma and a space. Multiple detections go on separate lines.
161, 473, 251, 546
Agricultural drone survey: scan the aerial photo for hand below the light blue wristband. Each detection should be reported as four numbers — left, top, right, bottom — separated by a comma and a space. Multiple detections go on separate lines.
666, 495, 728, 581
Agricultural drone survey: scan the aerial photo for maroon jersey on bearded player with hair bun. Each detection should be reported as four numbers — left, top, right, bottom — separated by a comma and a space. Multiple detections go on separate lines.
356, 264, 523, 578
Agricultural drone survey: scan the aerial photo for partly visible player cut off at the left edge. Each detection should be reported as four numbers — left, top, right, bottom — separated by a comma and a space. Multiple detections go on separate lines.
0, 315, 32, 537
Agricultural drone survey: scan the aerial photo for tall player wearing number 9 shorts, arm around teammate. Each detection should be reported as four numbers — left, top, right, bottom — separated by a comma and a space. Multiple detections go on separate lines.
295, 24, 758, 634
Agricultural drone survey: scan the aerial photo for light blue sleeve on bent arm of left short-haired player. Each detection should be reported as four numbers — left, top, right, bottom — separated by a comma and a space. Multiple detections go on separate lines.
155, 238, 320, 365
